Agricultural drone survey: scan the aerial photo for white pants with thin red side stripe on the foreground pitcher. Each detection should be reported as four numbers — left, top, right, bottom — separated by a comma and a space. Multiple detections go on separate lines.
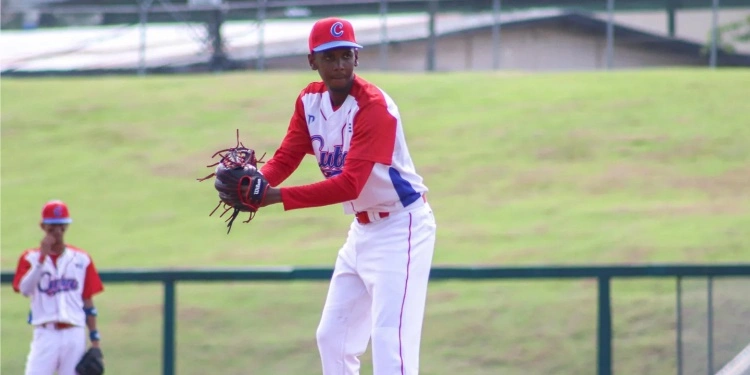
316, 203, 436, 375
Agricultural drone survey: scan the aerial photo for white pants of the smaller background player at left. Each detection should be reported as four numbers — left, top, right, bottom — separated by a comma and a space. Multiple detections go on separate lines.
26, 326, 86, 375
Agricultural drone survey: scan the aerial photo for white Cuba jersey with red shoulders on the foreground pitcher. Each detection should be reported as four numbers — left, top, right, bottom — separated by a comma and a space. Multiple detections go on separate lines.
296, 76, 427, 214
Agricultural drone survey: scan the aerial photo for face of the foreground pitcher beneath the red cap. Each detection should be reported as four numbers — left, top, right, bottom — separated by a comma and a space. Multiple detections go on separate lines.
308, 48, 358, 92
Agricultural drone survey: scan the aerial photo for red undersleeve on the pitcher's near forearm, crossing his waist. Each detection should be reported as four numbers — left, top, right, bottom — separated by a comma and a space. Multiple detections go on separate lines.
281, 157, 375, 210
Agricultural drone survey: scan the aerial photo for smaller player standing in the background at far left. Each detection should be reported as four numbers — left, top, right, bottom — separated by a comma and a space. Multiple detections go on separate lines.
13, 200, 104, 375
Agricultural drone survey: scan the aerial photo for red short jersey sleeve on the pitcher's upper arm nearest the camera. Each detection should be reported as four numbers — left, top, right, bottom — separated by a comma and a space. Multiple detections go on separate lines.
346, 103, 398, 165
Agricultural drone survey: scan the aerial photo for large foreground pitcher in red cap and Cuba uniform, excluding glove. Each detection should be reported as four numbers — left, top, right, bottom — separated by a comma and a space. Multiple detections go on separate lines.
253, 18, 436, 375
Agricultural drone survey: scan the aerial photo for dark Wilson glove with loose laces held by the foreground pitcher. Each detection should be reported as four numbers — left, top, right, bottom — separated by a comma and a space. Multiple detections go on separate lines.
198, 129, 268, 234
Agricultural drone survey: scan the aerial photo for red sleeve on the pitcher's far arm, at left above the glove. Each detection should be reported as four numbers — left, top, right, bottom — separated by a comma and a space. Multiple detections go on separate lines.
260, 95, 313, 187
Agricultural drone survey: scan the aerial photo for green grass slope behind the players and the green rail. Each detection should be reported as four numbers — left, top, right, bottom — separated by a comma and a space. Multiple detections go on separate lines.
0, 70, 750, 375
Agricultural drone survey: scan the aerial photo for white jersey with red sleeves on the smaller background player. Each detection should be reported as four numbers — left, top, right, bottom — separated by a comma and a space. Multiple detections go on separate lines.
13, 246, 103, 326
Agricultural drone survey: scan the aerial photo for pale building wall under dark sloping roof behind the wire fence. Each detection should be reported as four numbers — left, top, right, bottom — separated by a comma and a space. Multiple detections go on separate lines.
266, 20, 705, 71
